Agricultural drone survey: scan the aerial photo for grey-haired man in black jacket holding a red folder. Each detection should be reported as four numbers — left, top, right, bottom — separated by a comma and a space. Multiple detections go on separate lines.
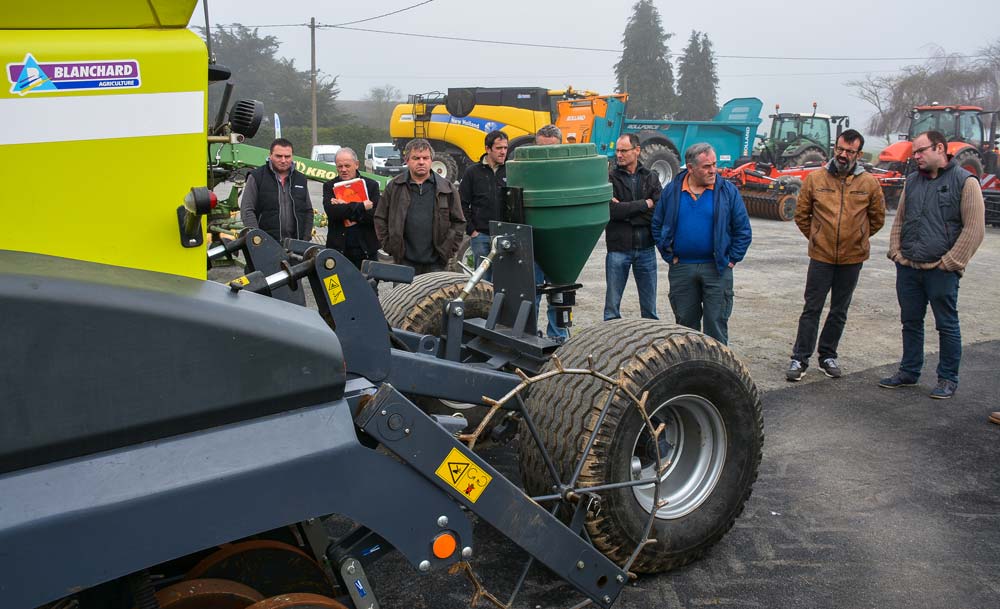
323, 148, 379, 269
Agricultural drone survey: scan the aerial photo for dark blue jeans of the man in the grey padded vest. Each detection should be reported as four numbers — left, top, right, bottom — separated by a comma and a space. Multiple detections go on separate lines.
896, 263, 962, 383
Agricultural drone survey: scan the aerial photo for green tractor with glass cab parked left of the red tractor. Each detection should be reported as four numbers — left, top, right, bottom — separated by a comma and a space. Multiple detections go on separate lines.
754, 102, 851, 169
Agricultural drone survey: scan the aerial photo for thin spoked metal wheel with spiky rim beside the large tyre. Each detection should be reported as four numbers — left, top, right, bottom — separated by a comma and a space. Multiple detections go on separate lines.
449, 355, 670, 609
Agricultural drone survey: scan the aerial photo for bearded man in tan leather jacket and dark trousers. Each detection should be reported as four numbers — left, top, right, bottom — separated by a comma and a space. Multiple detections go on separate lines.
785, 129, 885, 382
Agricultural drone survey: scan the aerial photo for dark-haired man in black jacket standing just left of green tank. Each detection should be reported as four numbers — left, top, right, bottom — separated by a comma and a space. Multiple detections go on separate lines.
458, 131, 507, 281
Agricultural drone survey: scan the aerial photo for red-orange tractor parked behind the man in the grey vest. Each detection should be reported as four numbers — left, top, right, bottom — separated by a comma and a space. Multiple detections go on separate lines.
878, 104, 998, 179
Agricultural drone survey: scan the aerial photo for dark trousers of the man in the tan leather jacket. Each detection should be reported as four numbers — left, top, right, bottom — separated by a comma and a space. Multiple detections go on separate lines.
792, 260, 862, 362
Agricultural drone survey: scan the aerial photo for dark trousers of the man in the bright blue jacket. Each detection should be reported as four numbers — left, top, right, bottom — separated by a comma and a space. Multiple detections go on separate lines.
667, 262, 733, 345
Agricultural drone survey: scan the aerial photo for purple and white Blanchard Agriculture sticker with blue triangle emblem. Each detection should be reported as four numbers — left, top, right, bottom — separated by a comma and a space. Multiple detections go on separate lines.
7, 53, 141, 95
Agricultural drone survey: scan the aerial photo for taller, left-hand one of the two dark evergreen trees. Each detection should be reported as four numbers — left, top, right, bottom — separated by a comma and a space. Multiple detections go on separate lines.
615, 0, 676, 119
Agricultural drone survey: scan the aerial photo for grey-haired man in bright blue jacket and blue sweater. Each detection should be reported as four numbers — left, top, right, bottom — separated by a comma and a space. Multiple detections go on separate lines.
652, 144, 752, 345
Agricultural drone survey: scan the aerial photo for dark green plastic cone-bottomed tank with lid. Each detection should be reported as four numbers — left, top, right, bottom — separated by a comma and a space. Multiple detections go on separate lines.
507, 144, 612, 285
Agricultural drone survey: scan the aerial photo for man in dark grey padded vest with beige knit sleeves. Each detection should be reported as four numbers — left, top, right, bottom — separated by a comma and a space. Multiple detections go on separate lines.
879, 131, 986, 399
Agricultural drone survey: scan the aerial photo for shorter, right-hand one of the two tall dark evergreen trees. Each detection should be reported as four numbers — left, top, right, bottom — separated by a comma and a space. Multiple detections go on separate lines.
677, 31, 719, 121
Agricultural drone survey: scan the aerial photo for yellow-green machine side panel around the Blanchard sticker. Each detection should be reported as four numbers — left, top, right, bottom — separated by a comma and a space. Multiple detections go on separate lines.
0, 30, 208, 278
